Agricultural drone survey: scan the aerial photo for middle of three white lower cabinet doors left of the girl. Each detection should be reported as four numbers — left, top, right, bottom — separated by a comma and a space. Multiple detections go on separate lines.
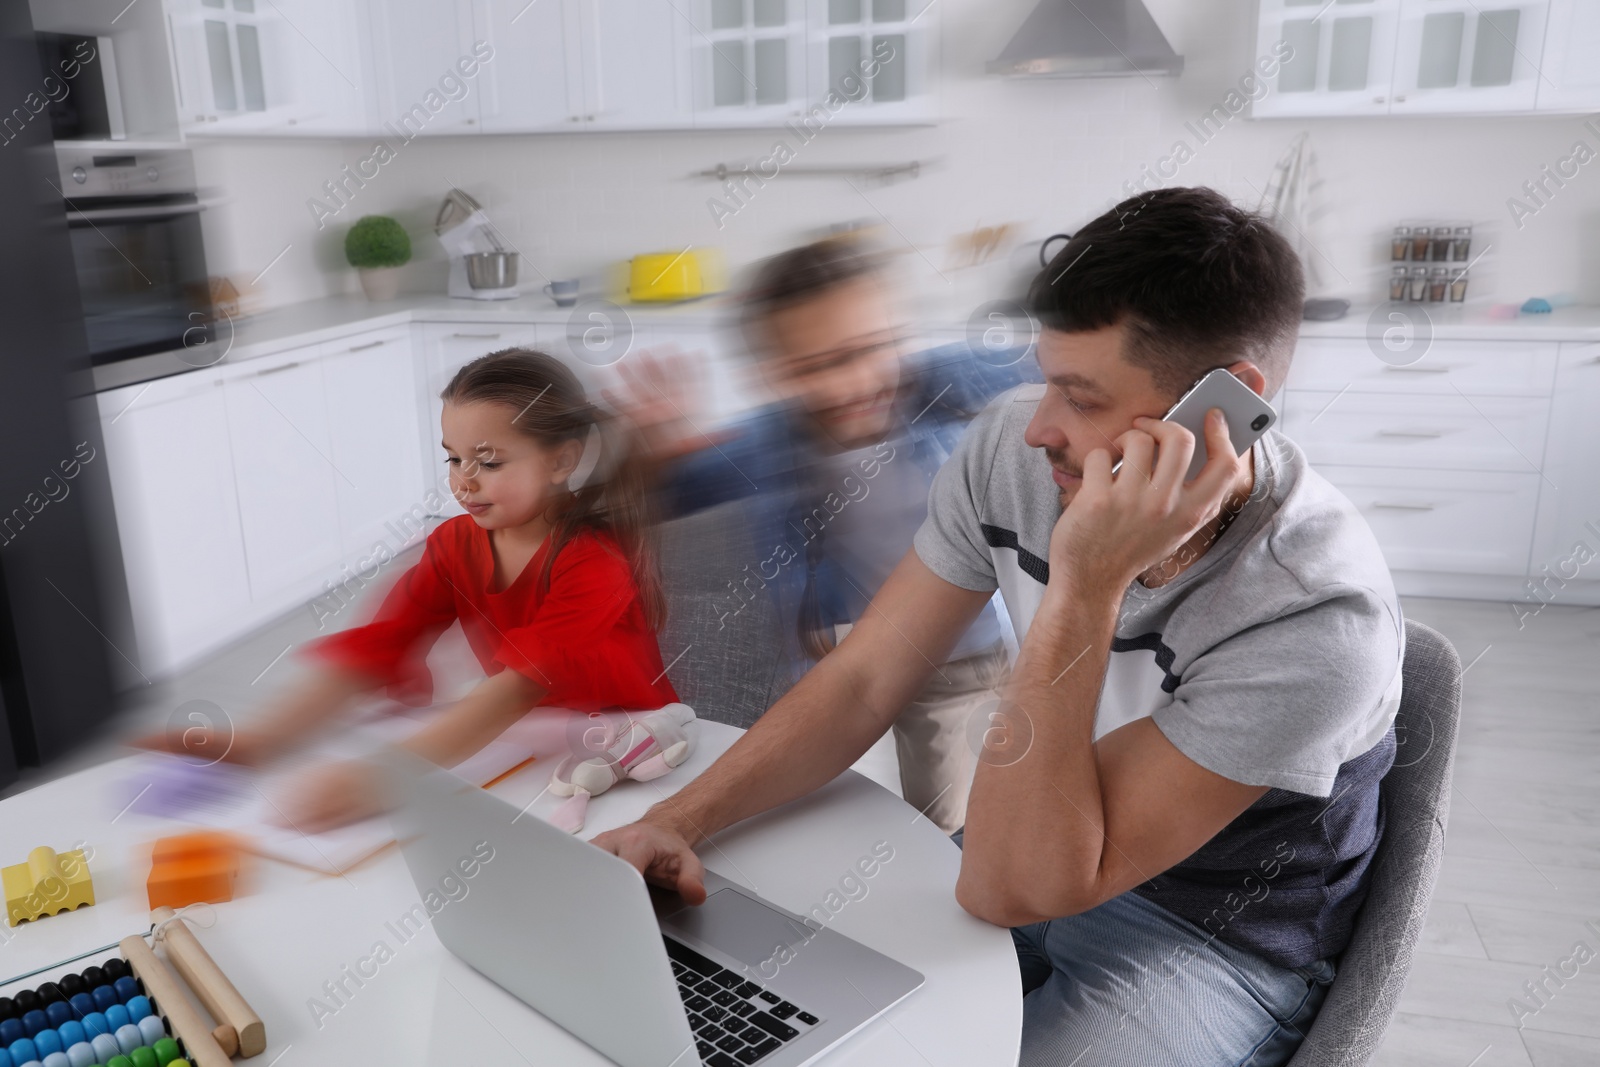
222, 347, 342, 609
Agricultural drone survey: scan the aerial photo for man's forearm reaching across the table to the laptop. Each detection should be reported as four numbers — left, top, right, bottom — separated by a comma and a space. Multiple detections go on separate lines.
645, 646, 899, 845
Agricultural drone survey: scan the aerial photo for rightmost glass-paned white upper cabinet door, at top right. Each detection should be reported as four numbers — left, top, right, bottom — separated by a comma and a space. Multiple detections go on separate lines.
1389, 0, 1548, 115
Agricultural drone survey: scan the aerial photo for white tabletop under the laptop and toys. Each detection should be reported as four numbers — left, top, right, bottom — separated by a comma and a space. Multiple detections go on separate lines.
0, 721, 1022, 1067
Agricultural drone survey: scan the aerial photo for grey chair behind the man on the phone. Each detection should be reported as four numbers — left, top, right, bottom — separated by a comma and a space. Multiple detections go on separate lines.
1290, 619, 1461, 1067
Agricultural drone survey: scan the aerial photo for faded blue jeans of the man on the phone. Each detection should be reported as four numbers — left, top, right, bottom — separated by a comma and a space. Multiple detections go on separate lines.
955, 835, 1334, 1067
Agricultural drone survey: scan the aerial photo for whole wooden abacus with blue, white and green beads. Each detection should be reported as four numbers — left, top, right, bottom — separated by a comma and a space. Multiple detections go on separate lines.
0, 909, 266, 1067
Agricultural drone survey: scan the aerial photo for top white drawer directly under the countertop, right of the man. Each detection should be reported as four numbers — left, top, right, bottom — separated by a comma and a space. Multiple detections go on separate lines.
1285, 338, 1557, 397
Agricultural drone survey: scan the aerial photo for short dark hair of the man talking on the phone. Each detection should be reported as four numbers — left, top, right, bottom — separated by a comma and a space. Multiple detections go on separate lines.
1027, 189, 1306, 400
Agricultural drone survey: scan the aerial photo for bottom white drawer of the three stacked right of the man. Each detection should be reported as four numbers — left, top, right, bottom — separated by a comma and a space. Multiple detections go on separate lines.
1317, 466, 1539, 576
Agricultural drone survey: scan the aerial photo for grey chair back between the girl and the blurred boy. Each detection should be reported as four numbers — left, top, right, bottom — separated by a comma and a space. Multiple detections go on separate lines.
658, 501, 790, 728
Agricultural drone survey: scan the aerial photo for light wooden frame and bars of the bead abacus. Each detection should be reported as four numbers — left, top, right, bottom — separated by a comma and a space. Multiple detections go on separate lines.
0, 907, 267, 1067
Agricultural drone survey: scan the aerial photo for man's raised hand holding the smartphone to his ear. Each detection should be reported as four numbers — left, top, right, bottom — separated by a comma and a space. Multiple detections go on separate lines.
1050, 408, 1250, 593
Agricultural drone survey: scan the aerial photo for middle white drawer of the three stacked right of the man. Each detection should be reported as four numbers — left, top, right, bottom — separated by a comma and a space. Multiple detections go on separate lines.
1283, 389, 1550, 474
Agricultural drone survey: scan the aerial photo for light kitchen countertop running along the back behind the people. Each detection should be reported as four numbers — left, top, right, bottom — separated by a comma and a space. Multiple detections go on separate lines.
93, 294, 1600, 392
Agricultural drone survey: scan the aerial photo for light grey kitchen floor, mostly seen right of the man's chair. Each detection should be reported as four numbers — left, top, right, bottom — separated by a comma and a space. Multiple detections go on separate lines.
6, 598, 1600, 1067
